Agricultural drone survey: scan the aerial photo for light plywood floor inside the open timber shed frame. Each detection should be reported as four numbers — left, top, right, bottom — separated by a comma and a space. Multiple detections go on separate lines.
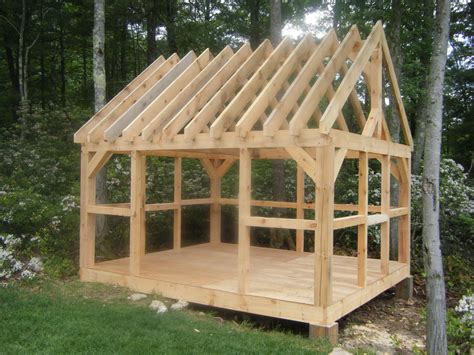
94, 243, 405, 304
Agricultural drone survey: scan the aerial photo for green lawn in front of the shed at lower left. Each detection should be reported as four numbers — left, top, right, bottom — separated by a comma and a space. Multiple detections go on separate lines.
0, 280, 331, 354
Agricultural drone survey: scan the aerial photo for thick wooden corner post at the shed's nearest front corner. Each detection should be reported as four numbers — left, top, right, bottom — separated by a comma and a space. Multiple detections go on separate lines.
314, 143, 335, 307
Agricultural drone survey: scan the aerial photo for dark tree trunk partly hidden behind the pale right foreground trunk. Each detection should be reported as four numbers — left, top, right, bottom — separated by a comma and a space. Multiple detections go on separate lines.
412, 0, 434, 175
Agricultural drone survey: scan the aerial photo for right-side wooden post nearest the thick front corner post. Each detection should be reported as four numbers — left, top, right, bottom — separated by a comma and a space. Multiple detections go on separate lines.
357, 152, 369, 287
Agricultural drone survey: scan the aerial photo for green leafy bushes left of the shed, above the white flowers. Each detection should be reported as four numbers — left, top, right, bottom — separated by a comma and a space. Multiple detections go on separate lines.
0, 109, 83, 280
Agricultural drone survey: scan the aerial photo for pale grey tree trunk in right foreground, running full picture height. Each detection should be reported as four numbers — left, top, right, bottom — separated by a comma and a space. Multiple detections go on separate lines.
422, 0, 450, 354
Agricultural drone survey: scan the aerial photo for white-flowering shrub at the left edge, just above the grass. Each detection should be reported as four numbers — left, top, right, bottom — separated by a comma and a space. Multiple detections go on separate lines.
0, 234, 43, 280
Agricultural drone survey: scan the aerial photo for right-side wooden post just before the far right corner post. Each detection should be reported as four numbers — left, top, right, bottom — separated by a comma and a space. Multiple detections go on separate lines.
380, 155, 391, 275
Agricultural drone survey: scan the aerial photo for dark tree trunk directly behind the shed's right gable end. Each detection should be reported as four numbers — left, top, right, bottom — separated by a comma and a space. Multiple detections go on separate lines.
388, 0, 403, 260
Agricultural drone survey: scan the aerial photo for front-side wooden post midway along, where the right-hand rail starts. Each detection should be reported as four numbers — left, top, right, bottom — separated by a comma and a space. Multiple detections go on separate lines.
238, 148, 252, 294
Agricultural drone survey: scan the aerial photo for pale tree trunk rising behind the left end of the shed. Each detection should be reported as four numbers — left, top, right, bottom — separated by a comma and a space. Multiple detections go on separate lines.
92, 0, 107, 245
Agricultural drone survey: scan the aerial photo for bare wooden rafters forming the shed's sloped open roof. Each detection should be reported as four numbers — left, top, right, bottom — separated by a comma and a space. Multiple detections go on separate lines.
74, 21, 413, 149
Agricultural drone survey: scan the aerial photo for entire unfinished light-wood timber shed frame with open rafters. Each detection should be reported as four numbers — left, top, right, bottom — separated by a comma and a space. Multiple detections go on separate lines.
74, 22, 413, 340
